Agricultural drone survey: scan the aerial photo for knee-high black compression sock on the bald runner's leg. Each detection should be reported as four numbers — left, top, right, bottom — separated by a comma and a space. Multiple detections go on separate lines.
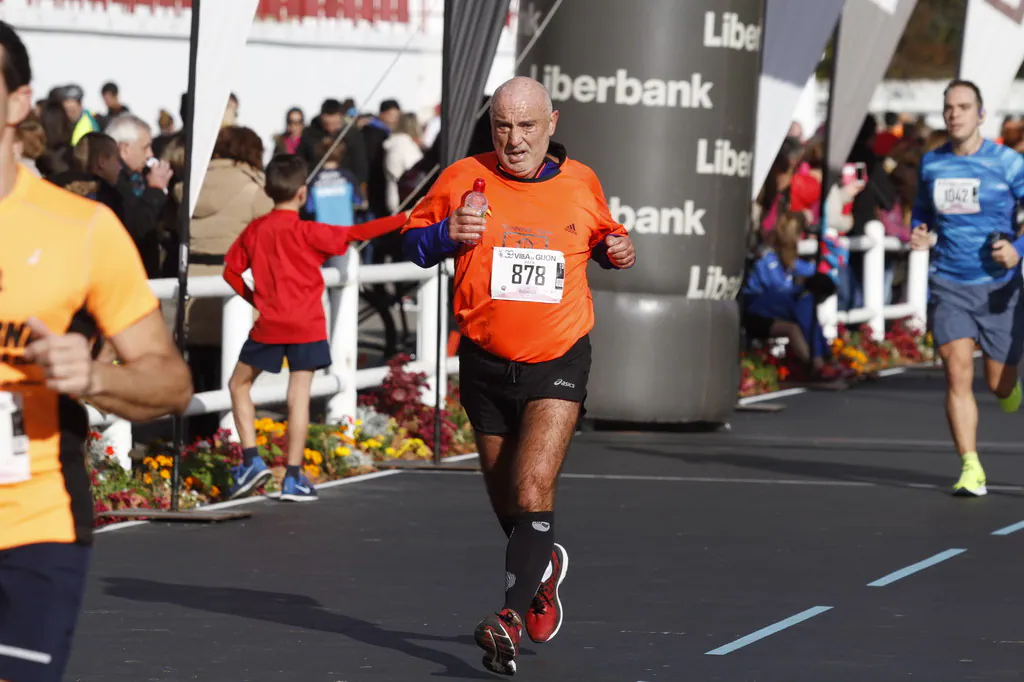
504, 512, 555, 621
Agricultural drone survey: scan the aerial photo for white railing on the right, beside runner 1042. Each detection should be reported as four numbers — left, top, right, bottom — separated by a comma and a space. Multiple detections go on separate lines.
799, 220, 928, 339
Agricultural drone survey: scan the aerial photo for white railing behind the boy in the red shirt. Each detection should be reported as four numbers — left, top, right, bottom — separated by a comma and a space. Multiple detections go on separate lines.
88, 250, 459, 468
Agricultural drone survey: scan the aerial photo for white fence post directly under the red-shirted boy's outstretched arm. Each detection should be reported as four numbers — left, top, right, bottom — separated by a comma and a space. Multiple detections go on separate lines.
327, 249, 359, 424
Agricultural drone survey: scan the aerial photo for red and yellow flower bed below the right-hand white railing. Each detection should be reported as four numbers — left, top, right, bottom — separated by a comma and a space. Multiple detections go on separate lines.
739, 319, 935, 397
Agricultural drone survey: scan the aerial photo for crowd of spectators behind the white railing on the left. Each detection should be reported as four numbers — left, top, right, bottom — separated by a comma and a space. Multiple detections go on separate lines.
15, 83, 437, 433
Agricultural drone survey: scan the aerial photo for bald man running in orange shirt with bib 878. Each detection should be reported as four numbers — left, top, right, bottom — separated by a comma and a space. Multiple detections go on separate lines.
404, 78, 635, 675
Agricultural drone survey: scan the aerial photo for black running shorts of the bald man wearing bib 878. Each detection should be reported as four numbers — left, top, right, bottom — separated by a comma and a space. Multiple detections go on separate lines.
459, 335, 591, 435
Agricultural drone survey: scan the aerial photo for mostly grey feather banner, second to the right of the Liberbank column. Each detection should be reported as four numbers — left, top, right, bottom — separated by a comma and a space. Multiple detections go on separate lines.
826, 0, 918, 186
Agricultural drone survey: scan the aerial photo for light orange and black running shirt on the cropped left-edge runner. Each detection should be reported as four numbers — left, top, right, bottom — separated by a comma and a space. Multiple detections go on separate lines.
0, 169, 158, 549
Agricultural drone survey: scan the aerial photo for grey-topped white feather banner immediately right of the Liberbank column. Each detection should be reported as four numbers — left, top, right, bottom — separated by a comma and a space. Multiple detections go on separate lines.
752, 0, 846, 198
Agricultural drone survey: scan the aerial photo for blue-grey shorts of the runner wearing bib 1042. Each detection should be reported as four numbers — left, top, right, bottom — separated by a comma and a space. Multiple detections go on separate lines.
928, 276, 1024, 366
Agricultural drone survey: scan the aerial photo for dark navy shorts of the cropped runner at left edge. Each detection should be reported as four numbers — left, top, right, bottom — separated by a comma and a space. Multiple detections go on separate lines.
0, 543, 91, 682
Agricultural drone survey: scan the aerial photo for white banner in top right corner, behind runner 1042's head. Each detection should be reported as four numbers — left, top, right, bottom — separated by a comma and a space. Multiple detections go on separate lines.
959, 0, 1024, 138
